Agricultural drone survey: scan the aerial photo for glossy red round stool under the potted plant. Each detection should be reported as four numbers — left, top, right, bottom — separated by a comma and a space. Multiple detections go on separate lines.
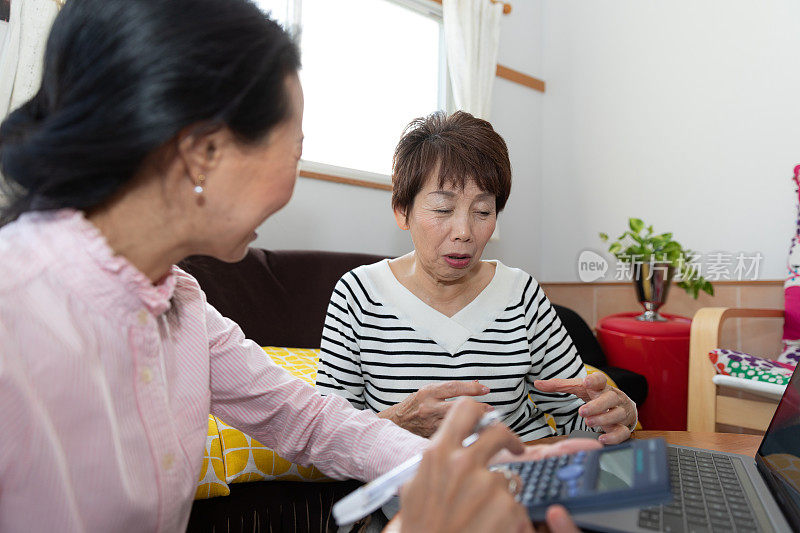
596, 313, 692, 431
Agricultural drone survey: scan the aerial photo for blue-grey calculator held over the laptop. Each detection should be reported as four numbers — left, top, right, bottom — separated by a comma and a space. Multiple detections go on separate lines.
495, 439, 672, 521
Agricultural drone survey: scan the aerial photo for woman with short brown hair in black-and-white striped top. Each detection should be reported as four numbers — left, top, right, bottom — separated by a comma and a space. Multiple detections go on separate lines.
317, 111, 636, 443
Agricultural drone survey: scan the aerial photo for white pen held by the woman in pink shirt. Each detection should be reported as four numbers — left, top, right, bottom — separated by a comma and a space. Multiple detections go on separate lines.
333, 411, 500, 526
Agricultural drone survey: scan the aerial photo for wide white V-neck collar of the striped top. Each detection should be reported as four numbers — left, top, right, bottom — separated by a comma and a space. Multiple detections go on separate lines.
362, 259, 522, 355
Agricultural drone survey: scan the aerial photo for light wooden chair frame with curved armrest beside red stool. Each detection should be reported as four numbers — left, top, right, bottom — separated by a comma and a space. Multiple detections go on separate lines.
687, 307, 783, 432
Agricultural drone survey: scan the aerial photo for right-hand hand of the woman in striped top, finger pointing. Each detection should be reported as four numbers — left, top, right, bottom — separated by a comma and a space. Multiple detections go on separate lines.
533, 372, 637, 444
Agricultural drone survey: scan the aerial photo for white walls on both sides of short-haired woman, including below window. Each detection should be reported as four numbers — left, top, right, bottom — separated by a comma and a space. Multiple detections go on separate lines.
255, 0, 800, 281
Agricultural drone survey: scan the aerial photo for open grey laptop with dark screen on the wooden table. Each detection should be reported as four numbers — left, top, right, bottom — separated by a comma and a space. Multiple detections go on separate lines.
573, 364, 800, 533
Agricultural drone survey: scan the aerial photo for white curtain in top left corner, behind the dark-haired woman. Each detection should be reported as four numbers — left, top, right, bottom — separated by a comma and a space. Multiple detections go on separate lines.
0, 0, 59, 118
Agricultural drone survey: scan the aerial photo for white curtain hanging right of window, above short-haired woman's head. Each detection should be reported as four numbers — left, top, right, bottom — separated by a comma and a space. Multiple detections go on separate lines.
442, 0, 503, 120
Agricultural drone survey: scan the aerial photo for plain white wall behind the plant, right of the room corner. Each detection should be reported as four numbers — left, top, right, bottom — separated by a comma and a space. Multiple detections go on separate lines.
540, 0, 800, 281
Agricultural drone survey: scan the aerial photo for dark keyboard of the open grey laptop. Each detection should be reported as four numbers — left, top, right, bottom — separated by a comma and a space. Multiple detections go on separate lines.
639, 446, 758, 533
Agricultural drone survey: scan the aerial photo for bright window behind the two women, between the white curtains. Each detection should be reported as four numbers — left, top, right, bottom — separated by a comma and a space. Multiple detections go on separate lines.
257, 0, 447, 183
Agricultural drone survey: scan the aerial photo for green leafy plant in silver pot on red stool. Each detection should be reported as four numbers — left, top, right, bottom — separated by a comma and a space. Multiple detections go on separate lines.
600, 218, 714, 321
